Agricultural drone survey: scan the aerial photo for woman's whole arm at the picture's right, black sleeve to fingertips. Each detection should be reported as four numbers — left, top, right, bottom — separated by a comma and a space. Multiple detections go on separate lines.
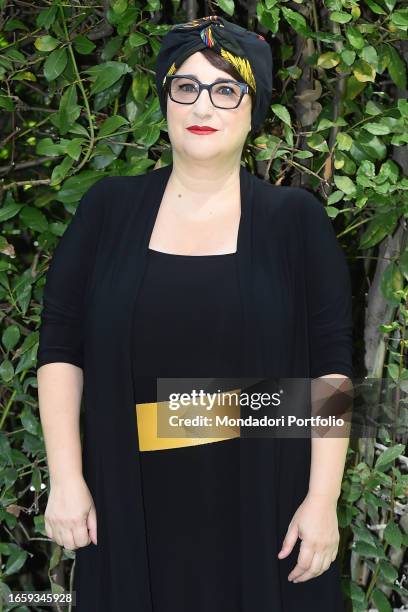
278, 190, 352, 582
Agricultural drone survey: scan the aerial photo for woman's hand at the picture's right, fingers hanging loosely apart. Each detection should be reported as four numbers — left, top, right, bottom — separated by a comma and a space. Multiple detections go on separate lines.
278, 493, 340, 582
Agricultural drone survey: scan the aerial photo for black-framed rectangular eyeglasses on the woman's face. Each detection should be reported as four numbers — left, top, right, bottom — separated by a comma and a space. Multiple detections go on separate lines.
165, 74, 249, 108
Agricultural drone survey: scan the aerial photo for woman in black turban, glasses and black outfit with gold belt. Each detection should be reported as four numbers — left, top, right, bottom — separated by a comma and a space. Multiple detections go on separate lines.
37, 16, 352, 612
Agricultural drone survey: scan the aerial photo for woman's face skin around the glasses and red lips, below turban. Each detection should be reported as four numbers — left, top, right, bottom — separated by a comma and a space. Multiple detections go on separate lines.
167, 51, 252, 160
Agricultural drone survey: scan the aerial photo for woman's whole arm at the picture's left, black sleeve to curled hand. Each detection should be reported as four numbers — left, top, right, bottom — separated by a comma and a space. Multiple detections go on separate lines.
37, 181, 108, 549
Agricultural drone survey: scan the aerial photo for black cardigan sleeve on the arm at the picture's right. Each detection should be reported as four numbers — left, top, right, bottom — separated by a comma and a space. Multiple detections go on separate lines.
301, 189, 353, 378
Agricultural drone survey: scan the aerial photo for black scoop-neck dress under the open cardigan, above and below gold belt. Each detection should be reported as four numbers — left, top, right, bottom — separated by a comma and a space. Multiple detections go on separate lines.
133, 249, 242, 612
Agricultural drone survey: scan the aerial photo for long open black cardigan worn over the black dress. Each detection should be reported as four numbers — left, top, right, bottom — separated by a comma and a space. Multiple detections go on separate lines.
37, 164, 352, 612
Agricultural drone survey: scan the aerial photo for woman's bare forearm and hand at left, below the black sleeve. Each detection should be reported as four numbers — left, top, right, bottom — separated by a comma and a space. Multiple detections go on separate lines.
37, 363, 97, 550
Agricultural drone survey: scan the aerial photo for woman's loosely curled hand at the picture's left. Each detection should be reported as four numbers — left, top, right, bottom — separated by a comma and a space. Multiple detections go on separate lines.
44, 476, 97, 550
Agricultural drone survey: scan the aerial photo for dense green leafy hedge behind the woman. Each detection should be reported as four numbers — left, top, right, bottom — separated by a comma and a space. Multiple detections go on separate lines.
0, 0, 408, 612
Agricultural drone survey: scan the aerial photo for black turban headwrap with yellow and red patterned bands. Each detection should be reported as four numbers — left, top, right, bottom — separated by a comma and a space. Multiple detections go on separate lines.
156, 15, 272, 134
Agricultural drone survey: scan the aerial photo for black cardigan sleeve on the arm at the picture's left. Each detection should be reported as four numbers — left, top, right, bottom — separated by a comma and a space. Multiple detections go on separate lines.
37, 177, 107, 369
